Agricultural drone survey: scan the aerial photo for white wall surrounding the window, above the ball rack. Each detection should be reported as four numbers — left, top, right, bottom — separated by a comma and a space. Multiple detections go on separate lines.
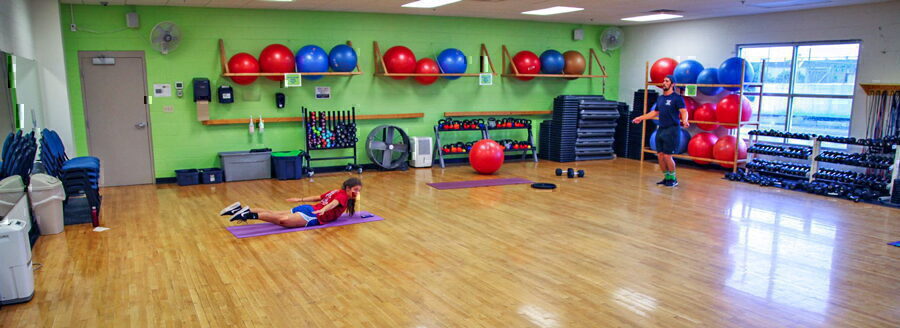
619, 1, 900, 136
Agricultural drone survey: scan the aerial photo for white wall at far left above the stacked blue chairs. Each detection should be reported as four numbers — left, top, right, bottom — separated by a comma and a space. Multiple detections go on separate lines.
0, 0, 76, 157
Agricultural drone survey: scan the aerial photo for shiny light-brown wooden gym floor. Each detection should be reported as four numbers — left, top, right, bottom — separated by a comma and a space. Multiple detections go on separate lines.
0, 159, 900, 328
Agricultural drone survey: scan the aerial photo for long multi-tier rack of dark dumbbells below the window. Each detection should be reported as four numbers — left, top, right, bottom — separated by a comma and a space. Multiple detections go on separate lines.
725, 130, 900, 206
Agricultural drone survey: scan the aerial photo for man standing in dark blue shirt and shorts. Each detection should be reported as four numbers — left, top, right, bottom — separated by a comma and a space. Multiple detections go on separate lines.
631, 75, 690, 187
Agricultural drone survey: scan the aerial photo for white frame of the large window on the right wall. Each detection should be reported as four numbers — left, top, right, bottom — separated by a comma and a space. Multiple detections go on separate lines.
734, 39, 862, 143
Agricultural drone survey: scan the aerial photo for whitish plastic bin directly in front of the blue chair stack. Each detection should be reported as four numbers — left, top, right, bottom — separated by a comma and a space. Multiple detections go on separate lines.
28, 174, 66, 235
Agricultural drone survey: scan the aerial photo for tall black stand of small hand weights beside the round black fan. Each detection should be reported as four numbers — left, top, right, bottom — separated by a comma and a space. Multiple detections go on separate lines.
301, 107, 363, 177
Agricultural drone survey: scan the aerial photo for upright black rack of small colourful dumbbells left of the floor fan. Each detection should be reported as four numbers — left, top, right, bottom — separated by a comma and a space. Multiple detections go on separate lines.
301, 107, 362, 177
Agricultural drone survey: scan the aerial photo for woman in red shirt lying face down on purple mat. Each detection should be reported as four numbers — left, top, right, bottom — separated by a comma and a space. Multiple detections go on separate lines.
219, 178, 362, 228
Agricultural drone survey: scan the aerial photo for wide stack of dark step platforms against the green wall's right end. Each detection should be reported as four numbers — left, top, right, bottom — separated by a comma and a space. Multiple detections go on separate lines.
541, 96, 619, 162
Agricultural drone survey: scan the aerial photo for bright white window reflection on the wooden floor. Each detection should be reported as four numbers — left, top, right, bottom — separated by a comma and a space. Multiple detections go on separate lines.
726, 202, 836, 313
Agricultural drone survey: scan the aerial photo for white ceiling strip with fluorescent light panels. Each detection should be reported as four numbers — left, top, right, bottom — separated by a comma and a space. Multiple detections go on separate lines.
62, 0, 891, 25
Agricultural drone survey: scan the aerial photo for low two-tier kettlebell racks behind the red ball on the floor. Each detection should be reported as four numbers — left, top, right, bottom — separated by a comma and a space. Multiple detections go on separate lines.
434, 117, 537, 168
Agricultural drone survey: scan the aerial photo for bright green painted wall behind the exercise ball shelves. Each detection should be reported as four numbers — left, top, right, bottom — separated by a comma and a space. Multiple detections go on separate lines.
61, 4, 619, 177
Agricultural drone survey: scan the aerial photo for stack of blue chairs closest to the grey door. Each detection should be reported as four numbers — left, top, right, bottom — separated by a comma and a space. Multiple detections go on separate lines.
41, 129, 101, 227
